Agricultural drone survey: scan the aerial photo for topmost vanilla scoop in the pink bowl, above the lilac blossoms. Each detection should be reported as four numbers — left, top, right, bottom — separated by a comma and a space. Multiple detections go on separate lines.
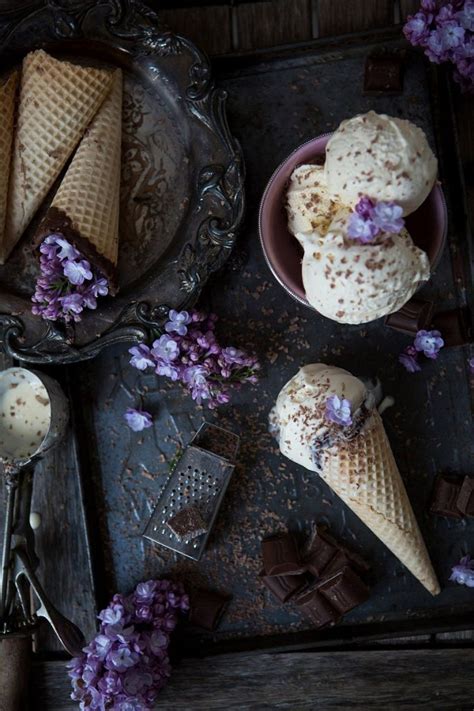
325, 111, 438, 215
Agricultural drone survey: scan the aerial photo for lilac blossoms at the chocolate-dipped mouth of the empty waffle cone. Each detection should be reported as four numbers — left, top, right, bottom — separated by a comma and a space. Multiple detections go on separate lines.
31, 234, 109, 322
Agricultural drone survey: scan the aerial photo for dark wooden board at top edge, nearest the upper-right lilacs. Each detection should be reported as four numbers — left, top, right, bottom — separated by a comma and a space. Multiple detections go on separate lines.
318, 0, 394, 37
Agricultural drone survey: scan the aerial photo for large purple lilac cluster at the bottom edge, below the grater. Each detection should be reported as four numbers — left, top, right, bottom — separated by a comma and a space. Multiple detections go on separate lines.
68, 580, 189, 711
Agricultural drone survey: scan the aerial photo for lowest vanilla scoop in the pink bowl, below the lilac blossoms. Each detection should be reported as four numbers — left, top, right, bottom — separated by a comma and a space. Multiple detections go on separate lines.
298, 208, 430, 324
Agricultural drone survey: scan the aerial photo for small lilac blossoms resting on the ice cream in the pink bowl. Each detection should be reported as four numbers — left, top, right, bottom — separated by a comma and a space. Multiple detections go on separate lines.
347, 197, 405, 244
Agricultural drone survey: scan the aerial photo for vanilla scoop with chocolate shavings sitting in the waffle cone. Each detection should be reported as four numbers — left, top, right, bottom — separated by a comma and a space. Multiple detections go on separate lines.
272, 363, 367, 471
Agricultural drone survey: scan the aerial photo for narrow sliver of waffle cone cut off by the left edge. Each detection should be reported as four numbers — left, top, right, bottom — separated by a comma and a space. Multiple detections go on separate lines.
0, 72, 18, 263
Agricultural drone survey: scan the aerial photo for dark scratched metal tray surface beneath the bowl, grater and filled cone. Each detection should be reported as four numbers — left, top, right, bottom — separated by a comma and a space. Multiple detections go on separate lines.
75, 37, 474, 644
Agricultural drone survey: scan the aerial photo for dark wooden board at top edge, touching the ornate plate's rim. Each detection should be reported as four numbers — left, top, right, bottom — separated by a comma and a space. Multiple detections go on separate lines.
158, 5, 232, 54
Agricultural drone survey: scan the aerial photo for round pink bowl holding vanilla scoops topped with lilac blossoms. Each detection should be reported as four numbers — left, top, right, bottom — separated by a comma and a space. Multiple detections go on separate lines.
259, 111, 447, 324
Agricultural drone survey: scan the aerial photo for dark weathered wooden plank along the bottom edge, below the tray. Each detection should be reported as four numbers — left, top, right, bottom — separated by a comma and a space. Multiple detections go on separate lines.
32, 649, 474, 711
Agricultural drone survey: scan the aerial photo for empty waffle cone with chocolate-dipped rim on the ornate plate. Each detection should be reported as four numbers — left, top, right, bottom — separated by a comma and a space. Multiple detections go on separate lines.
37, 69, 122, 288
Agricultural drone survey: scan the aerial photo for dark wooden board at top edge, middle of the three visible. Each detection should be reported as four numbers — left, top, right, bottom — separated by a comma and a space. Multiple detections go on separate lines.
235, 0, 312, 49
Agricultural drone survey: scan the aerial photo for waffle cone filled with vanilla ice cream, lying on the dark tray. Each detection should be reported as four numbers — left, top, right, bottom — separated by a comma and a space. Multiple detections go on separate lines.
272, 363, 440, 595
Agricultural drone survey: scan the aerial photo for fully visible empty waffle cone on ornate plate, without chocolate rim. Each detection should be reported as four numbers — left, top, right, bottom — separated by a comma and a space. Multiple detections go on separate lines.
2, 50, 112, 263
